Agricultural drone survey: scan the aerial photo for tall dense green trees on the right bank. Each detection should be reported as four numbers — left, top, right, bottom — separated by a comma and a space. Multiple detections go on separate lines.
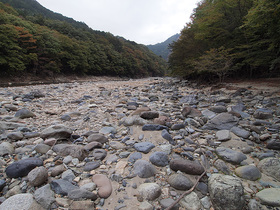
169, 0, 280, 81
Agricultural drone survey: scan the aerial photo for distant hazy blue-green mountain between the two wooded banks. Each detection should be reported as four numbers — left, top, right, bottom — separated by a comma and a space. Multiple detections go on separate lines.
147, 34, 180, 61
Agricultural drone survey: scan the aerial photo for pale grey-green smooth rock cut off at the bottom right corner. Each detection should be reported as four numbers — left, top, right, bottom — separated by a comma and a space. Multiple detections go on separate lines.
256, 188, 280, 207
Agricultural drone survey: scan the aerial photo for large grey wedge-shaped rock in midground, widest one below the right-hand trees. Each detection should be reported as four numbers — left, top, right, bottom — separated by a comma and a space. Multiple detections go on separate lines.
202, 113, 238, 130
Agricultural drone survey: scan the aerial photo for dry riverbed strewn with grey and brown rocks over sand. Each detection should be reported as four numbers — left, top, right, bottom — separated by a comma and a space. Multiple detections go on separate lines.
0, 78, 280, 210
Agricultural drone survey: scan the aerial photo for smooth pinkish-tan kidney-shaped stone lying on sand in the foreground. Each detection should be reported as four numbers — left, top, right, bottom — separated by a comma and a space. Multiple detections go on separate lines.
92, 174, 113, 198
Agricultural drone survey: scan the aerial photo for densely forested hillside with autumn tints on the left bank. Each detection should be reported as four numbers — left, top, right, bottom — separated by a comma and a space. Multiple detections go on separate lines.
0, 0, 166, 77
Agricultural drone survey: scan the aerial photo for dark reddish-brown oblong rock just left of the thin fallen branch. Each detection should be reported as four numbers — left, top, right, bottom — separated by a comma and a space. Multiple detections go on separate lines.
169, 159, 204, 175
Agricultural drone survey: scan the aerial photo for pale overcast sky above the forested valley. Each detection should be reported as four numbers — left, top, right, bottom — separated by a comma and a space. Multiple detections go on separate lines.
37, 0, 199, 44
